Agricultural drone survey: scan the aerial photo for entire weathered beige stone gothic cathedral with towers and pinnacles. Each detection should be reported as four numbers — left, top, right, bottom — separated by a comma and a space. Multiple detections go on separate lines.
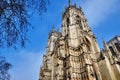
39, 2, 120, 80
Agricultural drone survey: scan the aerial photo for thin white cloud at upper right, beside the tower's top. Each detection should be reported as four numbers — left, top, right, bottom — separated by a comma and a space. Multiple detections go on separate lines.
76, 0, 120, 27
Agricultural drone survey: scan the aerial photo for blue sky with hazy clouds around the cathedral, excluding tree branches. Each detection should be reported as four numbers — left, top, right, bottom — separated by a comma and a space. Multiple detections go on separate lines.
0, 0, 120, 80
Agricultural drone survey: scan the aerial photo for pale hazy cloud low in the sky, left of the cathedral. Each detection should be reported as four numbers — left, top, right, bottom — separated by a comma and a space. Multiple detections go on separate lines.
10, 51, 43, 80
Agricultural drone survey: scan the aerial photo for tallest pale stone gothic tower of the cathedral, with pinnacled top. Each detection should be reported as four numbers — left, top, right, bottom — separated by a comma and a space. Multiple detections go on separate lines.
62, 2, 102, 80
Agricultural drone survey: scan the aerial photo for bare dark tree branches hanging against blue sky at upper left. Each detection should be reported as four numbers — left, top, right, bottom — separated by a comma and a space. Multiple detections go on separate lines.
0, 0, 49, 48
